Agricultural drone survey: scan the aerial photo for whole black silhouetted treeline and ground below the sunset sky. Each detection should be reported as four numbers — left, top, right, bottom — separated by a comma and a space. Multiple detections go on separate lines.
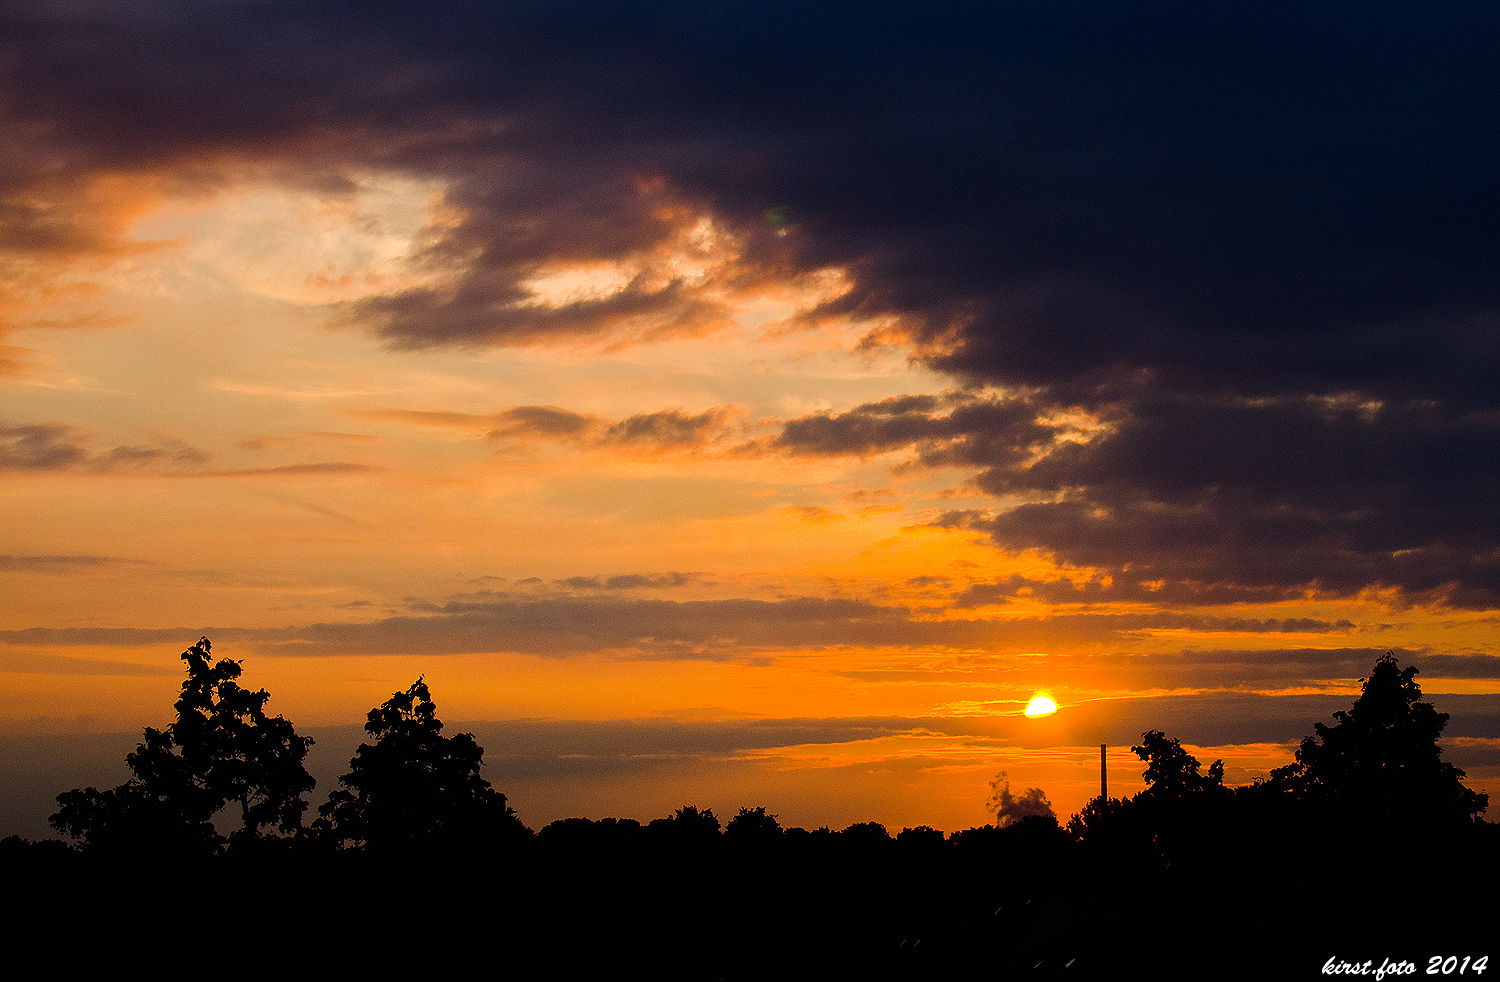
0, 639, 1500, 979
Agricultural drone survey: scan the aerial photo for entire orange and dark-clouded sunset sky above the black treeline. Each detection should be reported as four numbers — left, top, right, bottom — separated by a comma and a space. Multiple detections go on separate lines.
0, 0, 1500, 837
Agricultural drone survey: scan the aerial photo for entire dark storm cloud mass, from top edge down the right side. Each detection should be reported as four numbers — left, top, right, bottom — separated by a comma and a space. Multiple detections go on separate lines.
0, 0, 1500, 606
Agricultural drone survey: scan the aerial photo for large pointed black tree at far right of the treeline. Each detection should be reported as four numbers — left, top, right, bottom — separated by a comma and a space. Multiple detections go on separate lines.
1269, 652, 1490, 823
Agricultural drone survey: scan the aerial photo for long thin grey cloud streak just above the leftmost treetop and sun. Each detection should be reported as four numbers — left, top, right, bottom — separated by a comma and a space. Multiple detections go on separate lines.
0, 587, 1374, 661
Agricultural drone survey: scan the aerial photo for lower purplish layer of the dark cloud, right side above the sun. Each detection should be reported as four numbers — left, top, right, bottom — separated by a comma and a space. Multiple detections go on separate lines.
942, 396, 1500, 607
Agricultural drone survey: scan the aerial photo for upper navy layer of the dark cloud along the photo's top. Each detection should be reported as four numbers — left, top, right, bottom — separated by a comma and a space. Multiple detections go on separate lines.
6, 1, 1500, 380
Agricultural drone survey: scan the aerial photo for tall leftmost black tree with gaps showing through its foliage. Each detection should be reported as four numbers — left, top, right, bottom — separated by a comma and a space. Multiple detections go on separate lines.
51, 637, 314, 853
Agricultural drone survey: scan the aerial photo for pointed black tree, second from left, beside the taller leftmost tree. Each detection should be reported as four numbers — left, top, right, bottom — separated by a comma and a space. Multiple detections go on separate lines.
315, 678, 527, 852
